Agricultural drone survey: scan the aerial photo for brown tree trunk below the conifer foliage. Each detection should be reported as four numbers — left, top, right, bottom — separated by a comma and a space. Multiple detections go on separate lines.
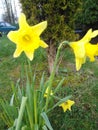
47, 43, 56, 74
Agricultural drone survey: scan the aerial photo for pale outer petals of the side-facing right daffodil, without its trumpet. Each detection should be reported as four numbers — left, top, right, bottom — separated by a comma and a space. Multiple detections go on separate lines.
69, 29, 98, 71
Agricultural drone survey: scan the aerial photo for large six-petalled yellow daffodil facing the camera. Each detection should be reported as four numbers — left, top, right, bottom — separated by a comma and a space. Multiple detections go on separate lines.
8, 13, 48, 60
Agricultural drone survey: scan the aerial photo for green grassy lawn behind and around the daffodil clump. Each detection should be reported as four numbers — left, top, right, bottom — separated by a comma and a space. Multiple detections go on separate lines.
0, 36, 98, 130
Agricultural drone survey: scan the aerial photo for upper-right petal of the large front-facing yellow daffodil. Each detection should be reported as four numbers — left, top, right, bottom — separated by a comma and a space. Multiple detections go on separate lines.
32, 21, 47, 36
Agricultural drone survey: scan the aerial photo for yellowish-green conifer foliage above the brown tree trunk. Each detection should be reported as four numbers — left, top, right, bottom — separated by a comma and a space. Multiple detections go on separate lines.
20, 0, 81, 44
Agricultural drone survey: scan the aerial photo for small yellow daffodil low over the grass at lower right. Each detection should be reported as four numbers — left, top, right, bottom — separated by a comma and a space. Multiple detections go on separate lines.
59, 100, 75, 112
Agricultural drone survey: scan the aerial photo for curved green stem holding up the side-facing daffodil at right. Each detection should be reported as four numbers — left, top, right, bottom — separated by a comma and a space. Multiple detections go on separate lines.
45, 41, 69, 112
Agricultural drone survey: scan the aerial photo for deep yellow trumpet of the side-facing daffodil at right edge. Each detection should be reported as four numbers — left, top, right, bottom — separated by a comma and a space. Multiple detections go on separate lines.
85, 43, 98, 61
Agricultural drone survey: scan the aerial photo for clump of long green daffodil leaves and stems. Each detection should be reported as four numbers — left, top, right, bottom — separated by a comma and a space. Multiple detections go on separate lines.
0, 40, 71, 130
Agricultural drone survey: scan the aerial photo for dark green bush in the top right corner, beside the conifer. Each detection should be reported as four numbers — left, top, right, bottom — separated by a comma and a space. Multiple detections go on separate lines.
76, 0, 98, 31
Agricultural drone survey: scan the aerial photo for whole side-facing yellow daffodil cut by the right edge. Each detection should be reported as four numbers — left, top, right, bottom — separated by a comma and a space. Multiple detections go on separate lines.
69, 29, 98, 71
